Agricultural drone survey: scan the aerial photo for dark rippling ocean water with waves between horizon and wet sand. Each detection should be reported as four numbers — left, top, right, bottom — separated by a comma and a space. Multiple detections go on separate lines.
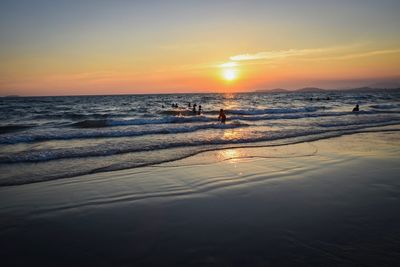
0, 90, 400, 186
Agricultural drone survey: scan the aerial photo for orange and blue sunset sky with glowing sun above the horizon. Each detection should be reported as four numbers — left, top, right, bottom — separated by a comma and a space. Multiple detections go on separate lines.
0, 0, 400, 95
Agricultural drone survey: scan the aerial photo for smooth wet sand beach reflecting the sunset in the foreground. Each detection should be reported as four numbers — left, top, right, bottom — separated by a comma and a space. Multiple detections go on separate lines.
0, 131, 400, 266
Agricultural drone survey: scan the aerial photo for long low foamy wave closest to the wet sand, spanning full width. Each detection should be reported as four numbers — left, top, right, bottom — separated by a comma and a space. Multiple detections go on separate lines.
0, 120, 400, 164
